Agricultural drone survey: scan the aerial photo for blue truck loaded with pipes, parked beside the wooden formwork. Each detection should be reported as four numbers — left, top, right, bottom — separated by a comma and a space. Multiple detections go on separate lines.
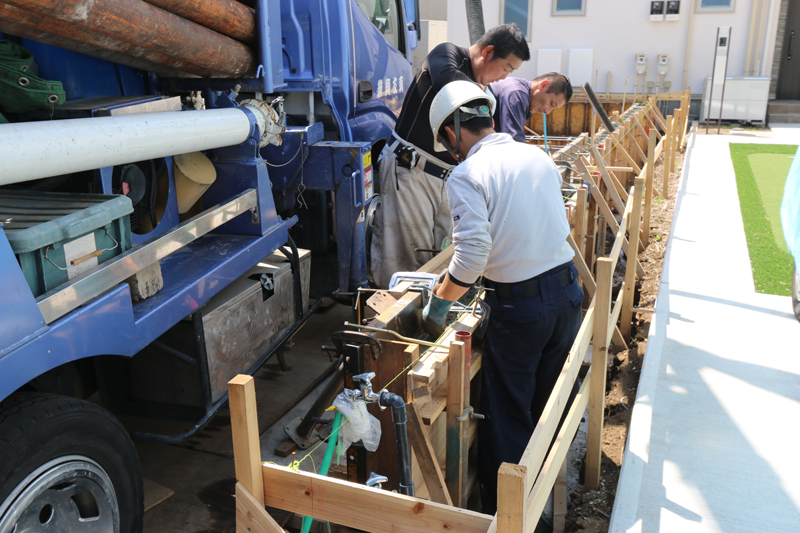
0, 0, 419, 533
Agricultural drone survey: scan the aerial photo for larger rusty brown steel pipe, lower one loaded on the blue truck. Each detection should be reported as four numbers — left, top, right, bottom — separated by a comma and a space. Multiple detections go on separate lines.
0, 0, 257, 78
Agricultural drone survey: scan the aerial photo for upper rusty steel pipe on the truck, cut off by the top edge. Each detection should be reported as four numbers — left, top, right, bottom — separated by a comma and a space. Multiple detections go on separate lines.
145, 0, 257, 45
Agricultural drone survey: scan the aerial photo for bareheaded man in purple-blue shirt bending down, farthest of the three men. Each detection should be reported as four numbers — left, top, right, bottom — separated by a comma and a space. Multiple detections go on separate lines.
489, 72, 572, 142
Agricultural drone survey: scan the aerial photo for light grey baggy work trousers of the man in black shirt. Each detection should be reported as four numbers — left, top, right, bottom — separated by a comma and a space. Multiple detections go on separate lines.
370, 142, 453, 289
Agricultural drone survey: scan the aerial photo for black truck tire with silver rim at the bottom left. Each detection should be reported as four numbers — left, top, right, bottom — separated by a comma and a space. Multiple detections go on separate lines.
0, 393, 144, 533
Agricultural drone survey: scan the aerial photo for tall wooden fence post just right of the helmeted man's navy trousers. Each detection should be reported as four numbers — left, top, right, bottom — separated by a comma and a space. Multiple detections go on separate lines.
586, 257, 614, 489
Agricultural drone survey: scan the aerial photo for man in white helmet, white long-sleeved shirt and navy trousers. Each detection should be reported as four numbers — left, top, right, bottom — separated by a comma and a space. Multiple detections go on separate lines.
423, 81, 583, 514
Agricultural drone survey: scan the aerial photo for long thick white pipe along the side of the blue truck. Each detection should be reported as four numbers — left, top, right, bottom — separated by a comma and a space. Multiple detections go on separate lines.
0, 108, 250, 185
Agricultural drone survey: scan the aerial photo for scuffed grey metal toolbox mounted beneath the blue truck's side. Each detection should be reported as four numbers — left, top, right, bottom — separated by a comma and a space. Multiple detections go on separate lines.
203, 250, 311, 403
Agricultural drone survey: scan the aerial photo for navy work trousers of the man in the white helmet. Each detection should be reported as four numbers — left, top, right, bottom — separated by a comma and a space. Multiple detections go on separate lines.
478, 262, 583, 514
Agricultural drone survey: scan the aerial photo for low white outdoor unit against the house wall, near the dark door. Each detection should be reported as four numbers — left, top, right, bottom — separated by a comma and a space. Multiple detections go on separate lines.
700, 77, 770, 122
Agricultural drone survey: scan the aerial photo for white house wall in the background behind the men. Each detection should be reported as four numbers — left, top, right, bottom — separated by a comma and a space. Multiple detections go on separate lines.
447, 0, 780, 94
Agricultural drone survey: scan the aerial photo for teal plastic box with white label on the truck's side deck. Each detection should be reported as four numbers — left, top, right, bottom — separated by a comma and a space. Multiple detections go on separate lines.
0, 191, 133, 296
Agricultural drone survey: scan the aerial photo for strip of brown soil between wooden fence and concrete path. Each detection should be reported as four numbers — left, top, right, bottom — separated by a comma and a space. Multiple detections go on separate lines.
566, 145, 684, 533
